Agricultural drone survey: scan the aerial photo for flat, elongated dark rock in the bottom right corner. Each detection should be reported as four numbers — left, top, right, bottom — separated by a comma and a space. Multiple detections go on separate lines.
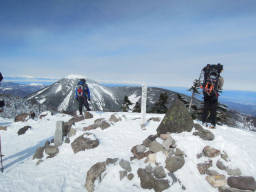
228, 176, 256, 191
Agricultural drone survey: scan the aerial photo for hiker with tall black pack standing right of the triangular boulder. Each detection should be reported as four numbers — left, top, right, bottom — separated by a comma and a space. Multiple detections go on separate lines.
200, 63, 224, 128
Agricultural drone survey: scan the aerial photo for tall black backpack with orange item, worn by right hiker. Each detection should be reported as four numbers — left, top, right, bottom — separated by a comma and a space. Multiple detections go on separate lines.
202, 64, 223, 96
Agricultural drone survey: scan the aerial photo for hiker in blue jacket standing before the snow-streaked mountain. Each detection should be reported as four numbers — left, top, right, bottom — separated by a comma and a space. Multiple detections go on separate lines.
75, 79, 91, 115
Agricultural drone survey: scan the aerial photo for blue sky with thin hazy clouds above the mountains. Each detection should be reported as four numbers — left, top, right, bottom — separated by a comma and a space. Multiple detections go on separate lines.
0, 0, 256, 91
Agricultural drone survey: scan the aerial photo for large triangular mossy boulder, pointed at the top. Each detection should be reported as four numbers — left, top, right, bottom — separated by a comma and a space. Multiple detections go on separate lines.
157, 99, 194, 135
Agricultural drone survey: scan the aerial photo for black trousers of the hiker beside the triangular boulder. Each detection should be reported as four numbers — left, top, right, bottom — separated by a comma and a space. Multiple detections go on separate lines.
202, 95, 218, 126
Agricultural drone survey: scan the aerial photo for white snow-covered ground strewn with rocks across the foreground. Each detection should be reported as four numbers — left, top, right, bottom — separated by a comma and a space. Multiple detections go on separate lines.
0, 112, 256, 192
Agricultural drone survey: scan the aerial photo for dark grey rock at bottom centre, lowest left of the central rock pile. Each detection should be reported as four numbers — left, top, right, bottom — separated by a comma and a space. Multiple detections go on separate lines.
137, 168, 155, 189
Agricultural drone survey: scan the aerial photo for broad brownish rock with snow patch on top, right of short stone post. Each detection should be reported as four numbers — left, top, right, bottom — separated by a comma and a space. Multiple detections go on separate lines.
71, 133, 99, 153
